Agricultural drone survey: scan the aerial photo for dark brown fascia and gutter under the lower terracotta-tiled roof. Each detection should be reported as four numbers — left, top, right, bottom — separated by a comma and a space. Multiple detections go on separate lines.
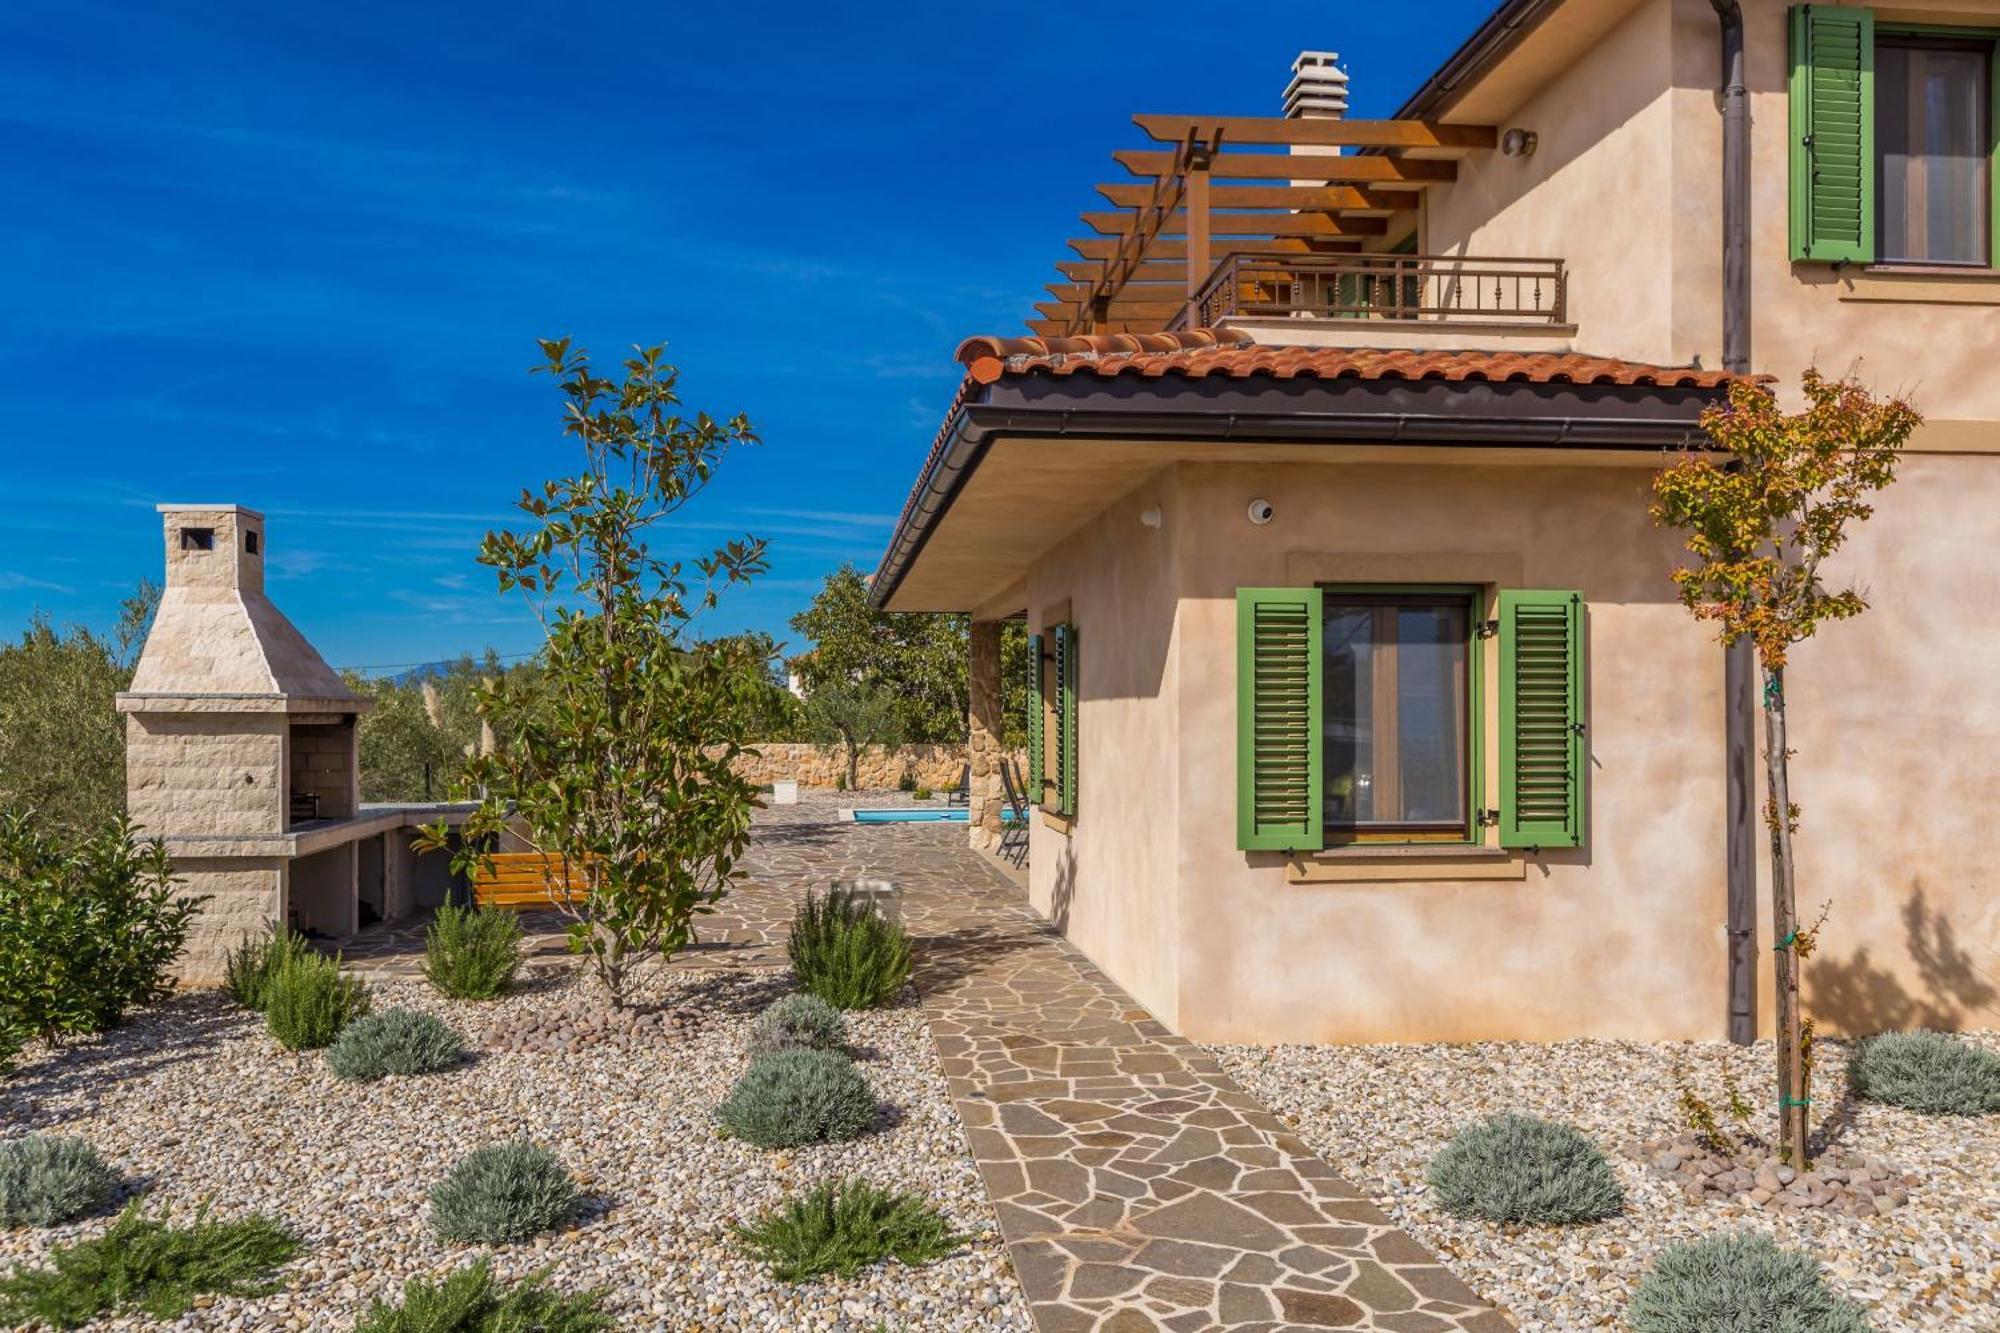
868, 374, 1728, 608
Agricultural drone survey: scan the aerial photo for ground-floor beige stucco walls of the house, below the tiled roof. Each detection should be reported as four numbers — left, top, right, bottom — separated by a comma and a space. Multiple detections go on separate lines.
1030, 458, 2000, 1041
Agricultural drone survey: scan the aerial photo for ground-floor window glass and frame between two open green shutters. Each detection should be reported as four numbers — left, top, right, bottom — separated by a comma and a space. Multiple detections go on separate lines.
1322, 596, 1468, 829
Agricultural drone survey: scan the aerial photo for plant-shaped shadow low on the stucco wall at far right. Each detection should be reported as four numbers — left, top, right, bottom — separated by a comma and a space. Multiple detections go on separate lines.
1806, 883, 2000, 1037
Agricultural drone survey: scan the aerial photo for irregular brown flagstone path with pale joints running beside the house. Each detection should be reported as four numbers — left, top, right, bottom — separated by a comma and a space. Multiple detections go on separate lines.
342, 797, 1514, 1333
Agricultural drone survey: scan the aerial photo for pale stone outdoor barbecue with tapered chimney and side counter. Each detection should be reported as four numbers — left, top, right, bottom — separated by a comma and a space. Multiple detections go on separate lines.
118, 504, 462, 981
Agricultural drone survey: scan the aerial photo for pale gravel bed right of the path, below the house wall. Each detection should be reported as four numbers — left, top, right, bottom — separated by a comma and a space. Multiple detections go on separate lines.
1214, 1033, 2000, 1333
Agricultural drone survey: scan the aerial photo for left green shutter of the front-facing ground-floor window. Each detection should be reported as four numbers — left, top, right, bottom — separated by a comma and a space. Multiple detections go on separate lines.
1236, 588, 1326, 851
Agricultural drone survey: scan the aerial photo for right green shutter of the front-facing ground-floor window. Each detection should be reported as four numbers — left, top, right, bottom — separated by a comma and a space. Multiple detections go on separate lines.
1500, 588, 1590, 847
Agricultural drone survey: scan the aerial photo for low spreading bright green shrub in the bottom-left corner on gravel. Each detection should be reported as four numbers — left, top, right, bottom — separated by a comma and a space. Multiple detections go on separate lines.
0, 1199, 298, 1329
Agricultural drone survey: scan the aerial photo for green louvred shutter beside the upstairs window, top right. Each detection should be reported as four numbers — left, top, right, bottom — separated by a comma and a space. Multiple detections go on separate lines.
1792, 4, 1876, 264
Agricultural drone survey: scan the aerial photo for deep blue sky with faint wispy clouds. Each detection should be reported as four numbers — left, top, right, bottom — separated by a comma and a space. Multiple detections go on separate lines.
0, 0, 1488, 667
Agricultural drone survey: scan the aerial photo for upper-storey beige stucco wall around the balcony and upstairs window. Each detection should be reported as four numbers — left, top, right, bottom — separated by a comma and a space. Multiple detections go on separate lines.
1422, 0, 2000, 426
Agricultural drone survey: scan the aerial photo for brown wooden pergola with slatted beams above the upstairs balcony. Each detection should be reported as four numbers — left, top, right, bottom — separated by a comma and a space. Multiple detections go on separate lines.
1028, 116, 1498, 336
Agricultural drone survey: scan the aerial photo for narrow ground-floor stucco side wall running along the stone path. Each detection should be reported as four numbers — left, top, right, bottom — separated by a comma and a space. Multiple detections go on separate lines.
1028, 470, 1186, 1025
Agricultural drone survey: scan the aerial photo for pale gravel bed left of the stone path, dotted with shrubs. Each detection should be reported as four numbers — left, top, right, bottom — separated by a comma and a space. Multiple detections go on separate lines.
0, 971, 1032, 1333
